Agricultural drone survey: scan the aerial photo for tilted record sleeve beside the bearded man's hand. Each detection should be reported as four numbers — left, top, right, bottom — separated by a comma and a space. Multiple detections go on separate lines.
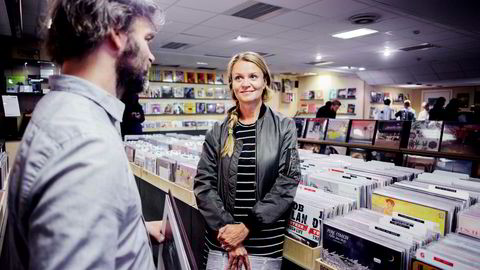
157, 191, 198, 270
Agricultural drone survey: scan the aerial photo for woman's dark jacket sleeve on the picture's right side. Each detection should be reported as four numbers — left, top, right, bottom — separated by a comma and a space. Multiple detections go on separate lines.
245, 119, 301, 230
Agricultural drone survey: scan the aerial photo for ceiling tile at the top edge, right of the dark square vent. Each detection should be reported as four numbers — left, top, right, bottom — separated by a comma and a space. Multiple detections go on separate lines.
300, 0, 369, 18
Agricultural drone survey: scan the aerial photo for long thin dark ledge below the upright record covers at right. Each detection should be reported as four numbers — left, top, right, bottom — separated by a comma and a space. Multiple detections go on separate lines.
298, 138, 480, 161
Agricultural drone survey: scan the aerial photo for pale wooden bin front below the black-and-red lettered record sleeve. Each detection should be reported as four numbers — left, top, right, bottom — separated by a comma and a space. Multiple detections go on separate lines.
283, 236, 322, 270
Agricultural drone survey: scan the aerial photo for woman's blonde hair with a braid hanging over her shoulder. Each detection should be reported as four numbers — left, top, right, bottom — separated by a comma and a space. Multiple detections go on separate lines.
221, 52, 273, 157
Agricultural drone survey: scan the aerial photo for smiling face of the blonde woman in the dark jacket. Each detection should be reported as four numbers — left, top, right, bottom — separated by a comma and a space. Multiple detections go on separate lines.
232, 61, 267, 103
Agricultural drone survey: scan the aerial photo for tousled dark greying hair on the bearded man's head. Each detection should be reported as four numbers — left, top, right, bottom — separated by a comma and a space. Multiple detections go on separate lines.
46, 0, 164, 64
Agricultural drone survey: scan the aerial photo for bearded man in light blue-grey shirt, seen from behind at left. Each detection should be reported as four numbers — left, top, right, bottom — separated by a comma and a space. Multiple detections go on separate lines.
6, 0, 163, 269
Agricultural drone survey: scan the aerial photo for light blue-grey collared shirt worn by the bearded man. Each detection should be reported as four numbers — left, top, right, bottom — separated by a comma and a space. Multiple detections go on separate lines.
8, 75, 155, 270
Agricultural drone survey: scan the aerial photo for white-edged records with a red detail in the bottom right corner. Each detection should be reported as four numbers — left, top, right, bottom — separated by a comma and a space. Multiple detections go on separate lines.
412, 233, 480, 270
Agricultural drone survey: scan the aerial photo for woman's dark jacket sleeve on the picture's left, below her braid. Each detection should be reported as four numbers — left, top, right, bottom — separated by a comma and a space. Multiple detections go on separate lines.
193, 125, 234, 231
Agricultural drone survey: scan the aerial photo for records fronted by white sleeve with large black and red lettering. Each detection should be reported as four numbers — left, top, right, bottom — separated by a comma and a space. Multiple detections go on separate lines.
287, 185, 356, 247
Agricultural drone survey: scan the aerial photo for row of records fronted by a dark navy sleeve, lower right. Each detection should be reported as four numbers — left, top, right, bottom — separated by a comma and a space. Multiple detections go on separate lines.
322, 209, 439, 270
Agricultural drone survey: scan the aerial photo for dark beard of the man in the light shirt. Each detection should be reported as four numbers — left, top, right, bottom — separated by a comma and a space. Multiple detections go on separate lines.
116, 38, 148, 95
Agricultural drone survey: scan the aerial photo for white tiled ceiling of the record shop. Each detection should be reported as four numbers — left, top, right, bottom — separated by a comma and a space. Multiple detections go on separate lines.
4, 0, 480, 87
